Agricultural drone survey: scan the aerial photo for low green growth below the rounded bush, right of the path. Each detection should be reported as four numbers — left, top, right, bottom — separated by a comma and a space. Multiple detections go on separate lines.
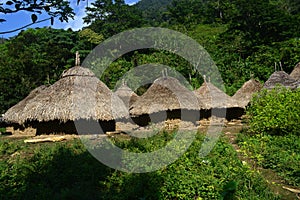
237, 134, 300, 187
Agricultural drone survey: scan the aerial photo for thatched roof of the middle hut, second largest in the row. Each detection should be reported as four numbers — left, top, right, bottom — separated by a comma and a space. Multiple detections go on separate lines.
130, 77, 203, 116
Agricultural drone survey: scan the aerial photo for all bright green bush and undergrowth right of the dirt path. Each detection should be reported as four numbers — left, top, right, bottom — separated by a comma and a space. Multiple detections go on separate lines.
237, 87, 300, 186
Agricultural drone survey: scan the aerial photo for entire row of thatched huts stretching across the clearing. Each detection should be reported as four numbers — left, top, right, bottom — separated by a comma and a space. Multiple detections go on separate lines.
3, 58, 300, 134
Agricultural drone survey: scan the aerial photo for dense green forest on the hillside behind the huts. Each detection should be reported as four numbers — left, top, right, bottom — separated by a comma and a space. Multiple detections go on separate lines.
0, 0, 300, 113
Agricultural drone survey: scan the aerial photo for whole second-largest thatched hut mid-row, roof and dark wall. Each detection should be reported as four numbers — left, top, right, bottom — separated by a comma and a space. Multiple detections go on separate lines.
130, 77, 203, 126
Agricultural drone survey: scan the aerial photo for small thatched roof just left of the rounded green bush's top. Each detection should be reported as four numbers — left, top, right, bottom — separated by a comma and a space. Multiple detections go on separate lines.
232, 79, 262, 108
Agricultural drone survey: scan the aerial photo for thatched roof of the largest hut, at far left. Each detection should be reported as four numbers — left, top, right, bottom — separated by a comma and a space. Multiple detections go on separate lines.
4, 66, 127, 124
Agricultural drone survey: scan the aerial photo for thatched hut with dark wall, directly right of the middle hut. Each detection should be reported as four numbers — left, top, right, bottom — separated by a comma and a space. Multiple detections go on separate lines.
194, 77, 244, 120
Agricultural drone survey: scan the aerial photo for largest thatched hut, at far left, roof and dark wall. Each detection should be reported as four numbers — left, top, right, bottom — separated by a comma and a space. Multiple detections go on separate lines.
4, 52, 127, 134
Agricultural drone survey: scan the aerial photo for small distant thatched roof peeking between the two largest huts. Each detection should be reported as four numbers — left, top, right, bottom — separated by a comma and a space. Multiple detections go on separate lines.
115, 82, 138, 108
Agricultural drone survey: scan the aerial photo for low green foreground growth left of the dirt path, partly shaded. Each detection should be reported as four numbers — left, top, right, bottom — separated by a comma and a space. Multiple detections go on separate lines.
0, 133, 279, 200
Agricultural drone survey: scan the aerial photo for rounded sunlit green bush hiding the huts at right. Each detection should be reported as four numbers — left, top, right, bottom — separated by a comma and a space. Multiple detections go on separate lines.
247, 87, 300, 135
